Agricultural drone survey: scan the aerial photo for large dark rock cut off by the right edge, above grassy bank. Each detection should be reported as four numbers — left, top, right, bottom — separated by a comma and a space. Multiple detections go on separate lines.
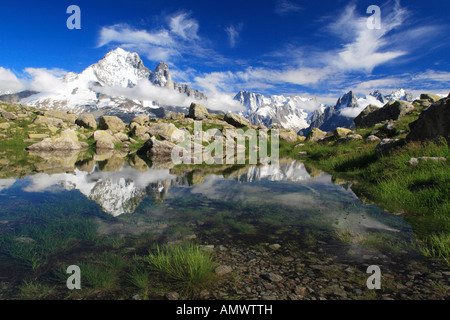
406, 95, 450, 141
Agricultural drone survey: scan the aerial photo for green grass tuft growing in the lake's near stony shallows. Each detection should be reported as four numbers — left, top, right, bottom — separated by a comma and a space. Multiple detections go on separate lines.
143, 242, 214, 292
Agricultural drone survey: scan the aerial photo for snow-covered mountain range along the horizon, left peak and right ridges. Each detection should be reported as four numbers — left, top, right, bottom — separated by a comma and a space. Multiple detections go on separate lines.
0, 48, 414, 135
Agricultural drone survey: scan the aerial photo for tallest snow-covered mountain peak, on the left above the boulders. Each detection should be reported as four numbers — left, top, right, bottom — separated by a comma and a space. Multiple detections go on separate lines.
1, 48, 207, 117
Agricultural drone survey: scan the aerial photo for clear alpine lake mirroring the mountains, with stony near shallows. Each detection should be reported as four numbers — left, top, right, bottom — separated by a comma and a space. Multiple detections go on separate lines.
0, 149, 450, 300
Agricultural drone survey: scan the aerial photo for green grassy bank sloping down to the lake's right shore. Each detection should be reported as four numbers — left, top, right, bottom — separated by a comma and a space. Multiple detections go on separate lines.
299, 136, 450, 262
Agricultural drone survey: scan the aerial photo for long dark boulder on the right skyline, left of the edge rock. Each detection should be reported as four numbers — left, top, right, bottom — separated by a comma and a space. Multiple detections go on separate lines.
353, 101, 414, 128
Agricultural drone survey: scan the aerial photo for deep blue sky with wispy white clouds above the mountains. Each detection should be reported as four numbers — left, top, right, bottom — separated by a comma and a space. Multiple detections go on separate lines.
0, 0, 450, 103
